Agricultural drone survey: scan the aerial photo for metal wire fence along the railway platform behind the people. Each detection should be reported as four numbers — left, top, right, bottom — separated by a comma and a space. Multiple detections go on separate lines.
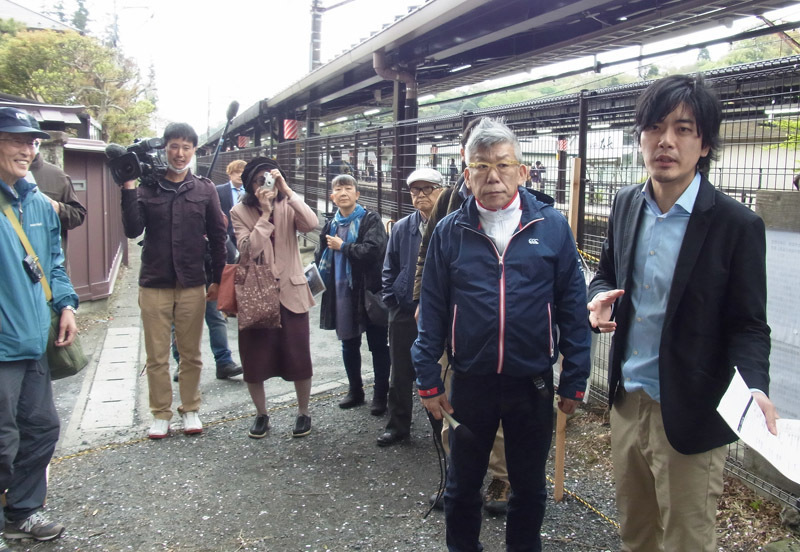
198, 57, 800, 507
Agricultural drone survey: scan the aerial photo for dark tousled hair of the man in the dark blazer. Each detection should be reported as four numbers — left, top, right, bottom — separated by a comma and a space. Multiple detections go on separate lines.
634, 74, 722, 174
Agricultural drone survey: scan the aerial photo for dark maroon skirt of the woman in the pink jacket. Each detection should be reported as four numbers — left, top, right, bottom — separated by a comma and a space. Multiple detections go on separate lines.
239, 305, 311, 383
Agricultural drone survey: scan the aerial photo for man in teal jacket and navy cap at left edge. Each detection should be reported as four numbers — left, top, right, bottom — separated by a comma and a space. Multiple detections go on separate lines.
0, 107, 78, 552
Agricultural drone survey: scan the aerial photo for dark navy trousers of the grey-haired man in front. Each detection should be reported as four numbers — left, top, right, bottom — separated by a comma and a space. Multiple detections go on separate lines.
444, 373, 553, 552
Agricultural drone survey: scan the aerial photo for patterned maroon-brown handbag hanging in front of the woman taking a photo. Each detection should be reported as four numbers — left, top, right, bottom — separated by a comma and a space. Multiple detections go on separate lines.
234, 243, 281, 331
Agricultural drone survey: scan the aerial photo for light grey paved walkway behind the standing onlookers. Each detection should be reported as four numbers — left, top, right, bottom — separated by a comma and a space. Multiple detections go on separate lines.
54, 241, 372, 454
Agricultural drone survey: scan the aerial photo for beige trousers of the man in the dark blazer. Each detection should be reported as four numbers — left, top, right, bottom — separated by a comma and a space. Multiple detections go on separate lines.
611, 390, 727, 552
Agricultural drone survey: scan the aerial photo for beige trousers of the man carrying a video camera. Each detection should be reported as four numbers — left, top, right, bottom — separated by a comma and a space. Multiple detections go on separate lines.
139, 284, 206, 420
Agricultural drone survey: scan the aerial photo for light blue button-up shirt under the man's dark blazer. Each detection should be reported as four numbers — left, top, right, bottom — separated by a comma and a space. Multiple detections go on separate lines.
622, 173, 700, 401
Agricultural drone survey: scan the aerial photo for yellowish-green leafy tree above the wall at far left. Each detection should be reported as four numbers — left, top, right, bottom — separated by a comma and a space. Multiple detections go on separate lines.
0, 26, 155, 143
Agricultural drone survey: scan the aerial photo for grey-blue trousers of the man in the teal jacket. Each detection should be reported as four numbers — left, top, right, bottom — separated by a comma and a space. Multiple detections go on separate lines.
0, 358, 59, 529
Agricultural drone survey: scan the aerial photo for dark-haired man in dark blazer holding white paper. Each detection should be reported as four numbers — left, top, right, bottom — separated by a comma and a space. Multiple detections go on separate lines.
588, 75, 777, 552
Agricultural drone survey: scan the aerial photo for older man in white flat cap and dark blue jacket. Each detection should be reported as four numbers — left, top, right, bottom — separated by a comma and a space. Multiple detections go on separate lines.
378, 169, 443, 447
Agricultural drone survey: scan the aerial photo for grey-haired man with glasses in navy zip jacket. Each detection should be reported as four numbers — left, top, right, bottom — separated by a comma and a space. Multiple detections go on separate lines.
412, 118, 590, 552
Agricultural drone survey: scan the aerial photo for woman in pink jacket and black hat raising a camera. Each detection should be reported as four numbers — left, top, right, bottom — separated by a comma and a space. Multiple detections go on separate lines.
231, 157, 317, 439
